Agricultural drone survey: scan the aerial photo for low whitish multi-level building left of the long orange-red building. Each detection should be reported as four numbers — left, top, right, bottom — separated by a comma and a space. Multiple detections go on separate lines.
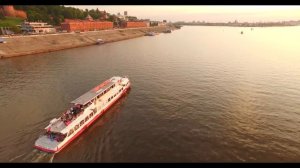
21, 21, 56, 34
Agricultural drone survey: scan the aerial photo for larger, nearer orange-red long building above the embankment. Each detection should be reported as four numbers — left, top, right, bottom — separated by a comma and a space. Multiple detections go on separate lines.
61, 16, 113, 32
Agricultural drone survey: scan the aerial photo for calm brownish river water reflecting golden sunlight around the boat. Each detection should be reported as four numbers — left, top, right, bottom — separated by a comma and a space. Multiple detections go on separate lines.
0, 26, 300, 162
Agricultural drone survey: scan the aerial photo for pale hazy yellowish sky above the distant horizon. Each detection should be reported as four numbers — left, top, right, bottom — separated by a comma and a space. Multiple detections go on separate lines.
68, 5, 300, 22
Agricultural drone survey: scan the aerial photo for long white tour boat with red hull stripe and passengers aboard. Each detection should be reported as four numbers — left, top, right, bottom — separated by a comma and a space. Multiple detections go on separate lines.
34, 77, 130, 153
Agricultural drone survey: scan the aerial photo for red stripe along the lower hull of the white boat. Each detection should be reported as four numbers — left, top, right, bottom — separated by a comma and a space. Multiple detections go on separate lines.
34, 86, 130, 153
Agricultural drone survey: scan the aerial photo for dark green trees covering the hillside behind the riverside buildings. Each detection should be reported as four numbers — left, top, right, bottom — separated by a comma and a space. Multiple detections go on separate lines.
14, 5, 114, 26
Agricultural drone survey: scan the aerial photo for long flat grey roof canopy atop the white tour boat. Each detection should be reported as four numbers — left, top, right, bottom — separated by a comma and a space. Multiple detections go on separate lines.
71, 80, 115, 105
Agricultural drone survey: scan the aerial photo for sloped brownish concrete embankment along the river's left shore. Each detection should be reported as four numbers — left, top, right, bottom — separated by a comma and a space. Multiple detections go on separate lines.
0, 26, 175, 58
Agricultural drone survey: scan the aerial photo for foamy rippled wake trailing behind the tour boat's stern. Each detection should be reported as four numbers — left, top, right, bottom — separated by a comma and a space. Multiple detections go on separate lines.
9, 149, 55, 163
